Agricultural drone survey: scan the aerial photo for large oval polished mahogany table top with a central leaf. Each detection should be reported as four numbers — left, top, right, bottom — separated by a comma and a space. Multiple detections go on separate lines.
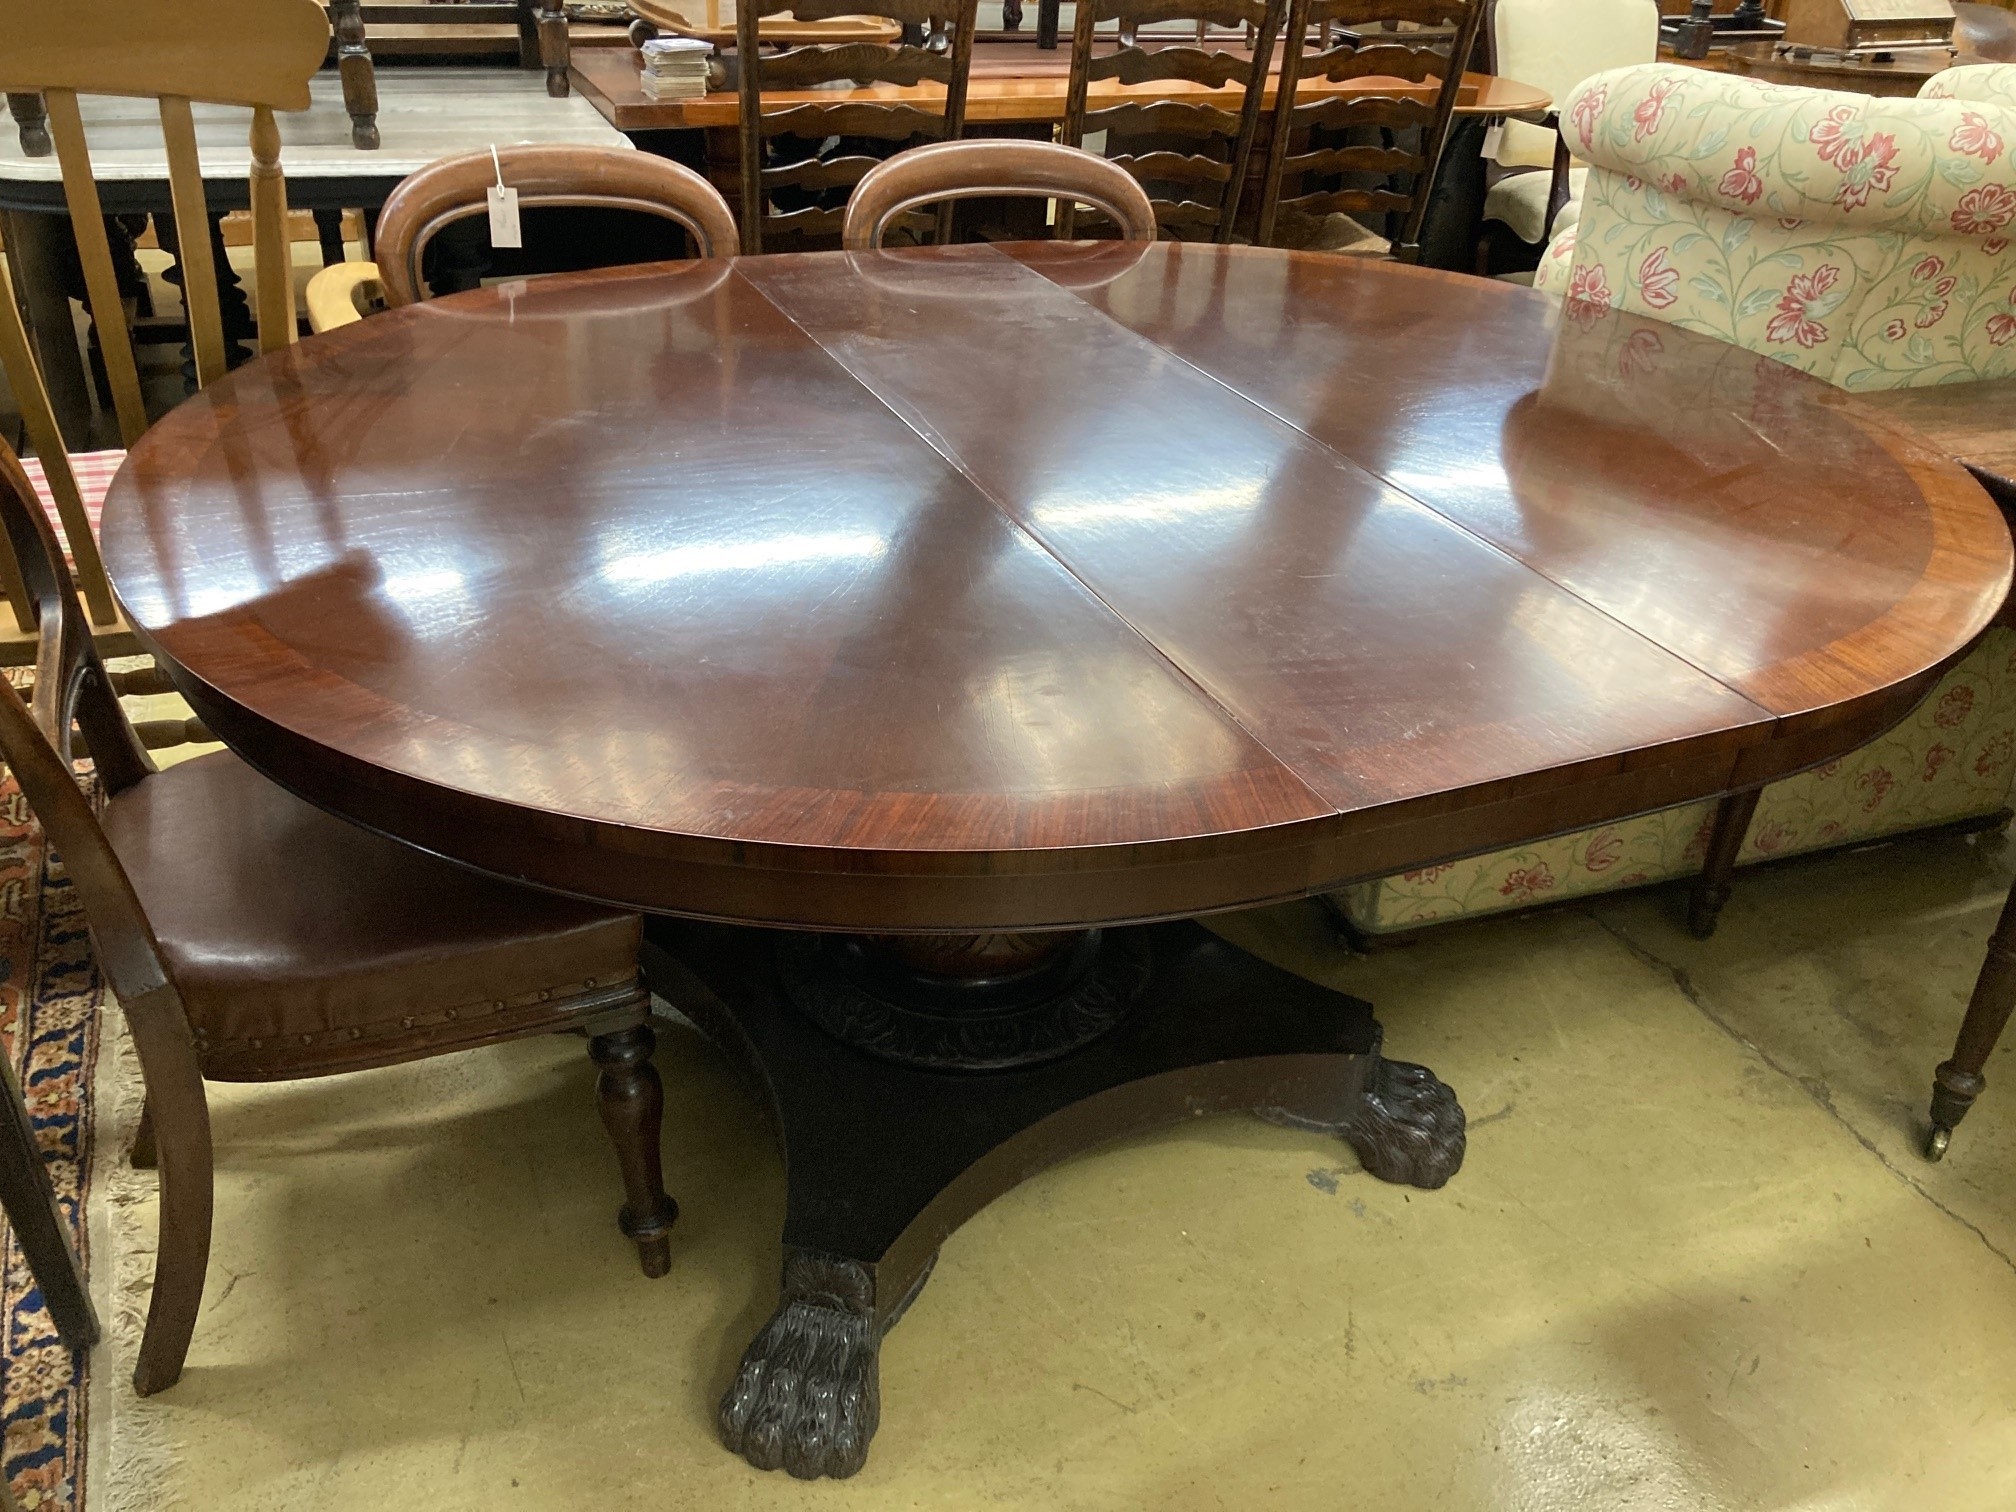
103, 242, 2010, 931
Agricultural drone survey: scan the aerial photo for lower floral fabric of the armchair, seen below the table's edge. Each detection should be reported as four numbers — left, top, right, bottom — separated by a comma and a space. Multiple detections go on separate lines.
1333, 625, 2016, 933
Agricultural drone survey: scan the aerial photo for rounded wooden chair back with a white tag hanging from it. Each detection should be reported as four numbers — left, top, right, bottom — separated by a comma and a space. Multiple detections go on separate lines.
308, 145, 738, 333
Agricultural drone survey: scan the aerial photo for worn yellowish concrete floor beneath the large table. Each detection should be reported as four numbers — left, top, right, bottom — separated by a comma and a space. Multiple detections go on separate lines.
93, 839, 2016, 1512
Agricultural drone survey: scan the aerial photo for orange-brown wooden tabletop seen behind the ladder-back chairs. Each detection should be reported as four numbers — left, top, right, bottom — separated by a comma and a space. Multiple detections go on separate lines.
573, 42, 1552, 131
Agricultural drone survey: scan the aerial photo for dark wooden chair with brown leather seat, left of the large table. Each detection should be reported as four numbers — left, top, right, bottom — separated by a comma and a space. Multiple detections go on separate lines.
0, 431, 677, 1395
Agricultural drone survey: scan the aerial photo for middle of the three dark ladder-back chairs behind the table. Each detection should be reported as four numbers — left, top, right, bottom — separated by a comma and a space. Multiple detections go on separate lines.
1056, 0, 1284, 242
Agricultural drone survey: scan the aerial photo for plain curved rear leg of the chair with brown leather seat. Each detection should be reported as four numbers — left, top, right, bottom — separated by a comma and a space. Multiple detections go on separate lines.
127, 1004, 212, 1397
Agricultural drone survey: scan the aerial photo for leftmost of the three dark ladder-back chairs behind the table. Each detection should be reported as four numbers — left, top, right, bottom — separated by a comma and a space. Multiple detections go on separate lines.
736, 0, 978, 252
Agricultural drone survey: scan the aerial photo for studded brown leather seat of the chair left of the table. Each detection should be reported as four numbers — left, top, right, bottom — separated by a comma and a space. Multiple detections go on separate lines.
101, 752, 643, 1081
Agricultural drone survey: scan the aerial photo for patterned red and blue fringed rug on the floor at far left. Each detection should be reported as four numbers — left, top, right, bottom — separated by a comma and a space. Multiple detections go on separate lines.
0, 774, 105, 1512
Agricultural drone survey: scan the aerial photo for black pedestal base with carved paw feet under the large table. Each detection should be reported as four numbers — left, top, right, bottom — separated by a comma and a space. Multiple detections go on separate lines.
645, 919, 1464, 1480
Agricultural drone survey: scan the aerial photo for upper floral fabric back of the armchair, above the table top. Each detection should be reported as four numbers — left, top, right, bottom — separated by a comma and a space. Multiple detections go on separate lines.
1534, 62, 2016, 389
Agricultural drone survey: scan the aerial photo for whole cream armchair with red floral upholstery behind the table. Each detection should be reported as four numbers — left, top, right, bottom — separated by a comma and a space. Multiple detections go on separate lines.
1333, 65, 2016, 935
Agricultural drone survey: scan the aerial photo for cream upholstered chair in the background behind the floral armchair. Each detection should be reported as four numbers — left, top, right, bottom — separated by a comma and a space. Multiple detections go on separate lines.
1484, 0, 1659, 258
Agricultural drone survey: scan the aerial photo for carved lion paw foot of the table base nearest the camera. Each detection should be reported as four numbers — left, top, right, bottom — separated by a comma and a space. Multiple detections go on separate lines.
720, 1256, 881, 1480
